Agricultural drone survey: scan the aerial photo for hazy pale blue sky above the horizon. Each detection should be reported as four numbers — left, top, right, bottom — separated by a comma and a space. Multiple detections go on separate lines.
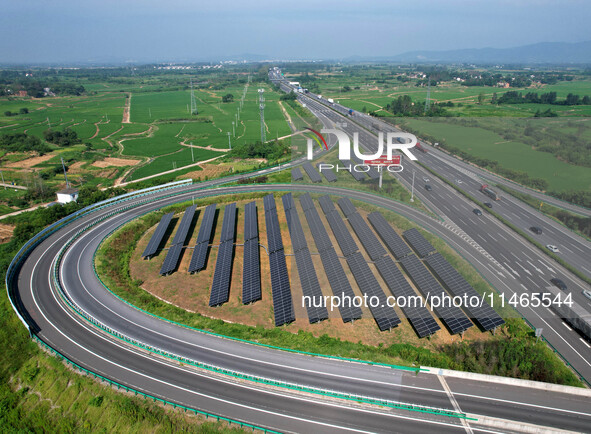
0, 0, 591, 64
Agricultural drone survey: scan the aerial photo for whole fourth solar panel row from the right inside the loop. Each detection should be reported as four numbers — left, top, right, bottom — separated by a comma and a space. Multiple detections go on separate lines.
320, 196, 400, 331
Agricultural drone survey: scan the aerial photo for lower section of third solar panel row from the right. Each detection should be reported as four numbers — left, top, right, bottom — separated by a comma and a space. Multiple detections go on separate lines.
375, 256, 441, 338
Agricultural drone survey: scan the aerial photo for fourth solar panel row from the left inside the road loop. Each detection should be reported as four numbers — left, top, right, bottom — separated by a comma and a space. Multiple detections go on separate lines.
209, 203, 236, 306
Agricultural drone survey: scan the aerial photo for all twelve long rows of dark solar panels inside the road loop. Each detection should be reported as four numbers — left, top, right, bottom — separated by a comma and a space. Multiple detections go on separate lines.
144, 194, 504, 337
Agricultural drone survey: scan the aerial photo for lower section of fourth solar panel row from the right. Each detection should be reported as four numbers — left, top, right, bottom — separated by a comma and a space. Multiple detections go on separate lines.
347, 252, 401, 331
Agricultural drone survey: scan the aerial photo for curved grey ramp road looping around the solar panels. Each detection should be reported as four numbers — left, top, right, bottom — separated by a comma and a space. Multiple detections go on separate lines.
11, 181, 591, 432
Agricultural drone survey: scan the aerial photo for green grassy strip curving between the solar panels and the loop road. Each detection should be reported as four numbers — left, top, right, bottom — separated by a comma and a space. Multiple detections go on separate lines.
96, 193, 581, 386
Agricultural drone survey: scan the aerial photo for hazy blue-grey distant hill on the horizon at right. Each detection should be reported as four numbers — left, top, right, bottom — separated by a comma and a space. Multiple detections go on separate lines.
351, 41, 591, 64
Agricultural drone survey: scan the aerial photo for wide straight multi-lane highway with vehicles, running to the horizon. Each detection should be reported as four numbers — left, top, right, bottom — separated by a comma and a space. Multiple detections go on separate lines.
273, 69, 591, 379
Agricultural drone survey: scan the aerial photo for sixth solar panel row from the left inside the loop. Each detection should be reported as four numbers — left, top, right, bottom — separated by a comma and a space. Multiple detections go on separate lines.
263, 194, 295, 326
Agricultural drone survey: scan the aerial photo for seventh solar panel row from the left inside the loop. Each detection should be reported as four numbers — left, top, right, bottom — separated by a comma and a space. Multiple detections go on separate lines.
282, 193, 328, 323
